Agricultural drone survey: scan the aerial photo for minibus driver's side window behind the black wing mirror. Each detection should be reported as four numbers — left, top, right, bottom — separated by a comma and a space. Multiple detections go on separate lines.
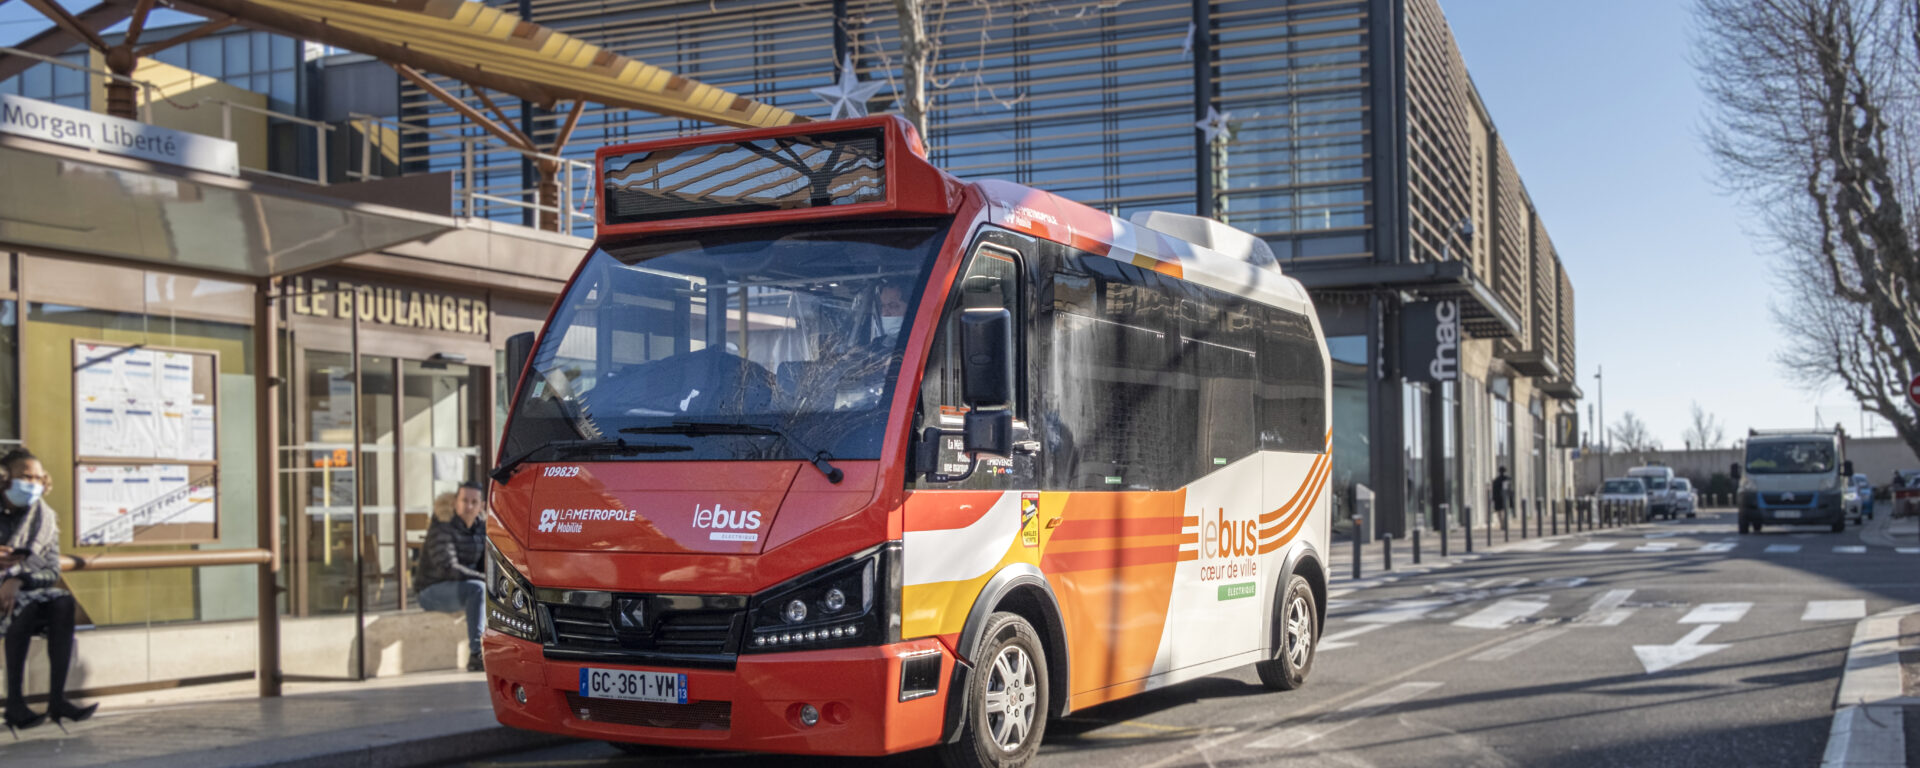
912, 246, 1037, 490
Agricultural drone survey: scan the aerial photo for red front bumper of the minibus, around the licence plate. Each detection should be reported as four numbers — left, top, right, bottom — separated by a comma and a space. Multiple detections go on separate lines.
484, 630, 954, 755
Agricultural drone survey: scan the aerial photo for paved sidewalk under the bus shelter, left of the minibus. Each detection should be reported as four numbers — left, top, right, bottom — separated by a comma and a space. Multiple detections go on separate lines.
0, 672, 561, 768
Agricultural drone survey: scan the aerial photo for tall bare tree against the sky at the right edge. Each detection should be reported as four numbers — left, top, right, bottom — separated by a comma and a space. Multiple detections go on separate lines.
1695, 0, 1920, 458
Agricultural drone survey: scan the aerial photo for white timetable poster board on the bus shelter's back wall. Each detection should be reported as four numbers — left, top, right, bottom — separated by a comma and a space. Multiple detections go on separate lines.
73, 340, 219, 547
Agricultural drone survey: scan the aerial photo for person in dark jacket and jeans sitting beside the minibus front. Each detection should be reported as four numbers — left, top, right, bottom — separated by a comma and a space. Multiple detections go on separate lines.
415, 482, 486, 672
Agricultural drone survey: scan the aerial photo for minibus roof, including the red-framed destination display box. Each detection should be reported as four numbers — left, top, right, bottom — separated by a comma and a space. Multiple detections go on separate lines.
595, 115, 1317, 323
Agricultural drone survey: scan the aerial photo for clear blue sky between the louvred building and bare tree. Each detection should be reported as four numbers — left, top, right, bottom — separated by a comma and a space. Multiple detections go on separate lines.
0, 0, 1891, 447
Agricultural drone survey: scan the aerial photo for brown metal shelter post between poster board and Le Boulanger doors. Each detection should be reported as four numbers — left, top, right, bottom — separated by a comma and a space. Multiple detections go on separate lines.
253, 278, 280, 699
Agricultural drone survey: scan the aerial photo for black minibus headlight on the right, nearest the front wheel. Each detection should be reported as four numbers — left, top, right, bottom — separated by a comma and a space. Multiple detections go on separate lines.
741, 547, 899, 653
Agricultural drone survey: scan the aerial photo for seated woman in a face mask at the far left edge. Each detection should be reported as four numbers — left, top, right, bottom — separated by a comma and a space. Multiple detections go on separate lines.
0, 447, 100, 737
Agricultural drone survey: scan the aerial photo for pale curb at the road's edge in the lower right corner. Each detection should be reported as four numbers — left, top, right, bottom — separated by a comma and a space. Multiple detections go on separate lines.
1820, 605, 1920, 768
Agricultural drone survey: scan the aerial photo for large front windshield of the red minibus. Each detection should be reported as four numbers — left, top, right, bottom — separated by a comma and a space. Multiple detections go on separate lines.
501, 223, 947, 461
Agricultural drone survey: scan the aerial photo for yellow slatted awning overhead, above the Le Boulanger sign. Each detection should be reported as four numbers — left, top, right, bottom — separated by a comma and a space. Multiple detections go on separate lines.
177, 0, 806, 127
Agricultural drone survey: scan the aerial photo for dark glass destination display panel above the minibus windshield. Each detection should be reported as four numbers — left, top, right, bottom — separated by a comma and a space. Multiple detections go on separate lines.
601, 129, 887, 225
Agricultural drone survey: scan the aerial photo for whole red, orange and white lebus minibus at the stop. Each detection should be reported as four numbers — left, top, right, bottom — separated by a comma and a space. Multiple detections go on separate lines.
484, 117, 1331, 766
